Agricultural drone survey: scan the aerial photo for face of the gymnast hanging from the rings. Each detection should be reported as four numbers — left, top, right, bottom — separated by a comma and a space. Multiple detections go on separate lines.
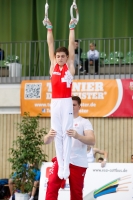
55, 52, 68, 66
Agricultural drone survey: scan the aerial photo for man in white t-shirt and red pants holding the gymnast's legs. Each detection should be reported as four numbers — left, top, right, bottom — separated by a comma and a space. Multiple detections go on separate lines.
44, 96, 95, 200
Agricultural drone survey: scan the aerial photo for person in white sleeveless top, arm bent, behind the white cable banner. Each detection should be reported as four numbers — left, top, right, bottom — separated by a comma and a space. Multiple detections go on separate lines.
87, 145, 108, 167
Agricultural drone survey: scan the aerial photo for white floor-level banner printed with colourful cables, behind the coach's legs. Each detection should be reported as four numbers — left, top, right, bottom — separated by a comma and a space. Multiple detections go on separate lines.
38, 162, 133, 200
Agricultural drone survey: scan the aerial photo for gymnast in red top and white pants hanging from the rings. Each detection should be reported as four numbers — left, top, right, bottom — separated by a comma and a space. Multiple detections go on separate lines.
43, 15, 77, 179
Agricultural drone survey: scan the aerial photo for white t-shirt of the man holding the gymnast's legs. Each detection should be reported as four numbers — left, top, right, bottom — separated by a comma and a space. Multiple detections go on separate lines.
70, 116, 93, 168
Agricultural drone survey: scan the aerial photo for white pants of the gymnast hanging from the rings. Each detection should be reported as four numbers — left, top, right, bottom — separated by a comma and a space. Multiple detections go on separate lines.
51, 98, 73, 175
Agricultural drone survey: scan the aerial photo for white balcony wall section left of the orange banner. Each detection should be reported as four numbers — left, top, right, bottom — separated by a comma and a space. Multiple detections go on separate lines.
0, 84, 20, 114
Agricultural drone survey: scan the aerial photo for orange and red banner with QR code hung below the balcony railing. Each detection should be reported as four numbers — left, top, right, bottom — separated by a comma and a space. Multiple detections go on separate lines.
21, 79, 133, 117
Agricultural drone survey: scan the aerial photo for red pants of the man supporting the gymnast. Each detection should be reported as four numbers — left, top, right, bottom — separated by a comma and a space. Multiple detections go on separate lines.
45, 158, 87, 200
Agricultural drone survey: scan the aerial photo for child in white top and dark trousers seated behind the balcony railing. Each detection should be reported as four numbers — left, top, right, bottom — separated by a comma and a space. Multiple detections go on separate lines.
85, 43, 99, 74
